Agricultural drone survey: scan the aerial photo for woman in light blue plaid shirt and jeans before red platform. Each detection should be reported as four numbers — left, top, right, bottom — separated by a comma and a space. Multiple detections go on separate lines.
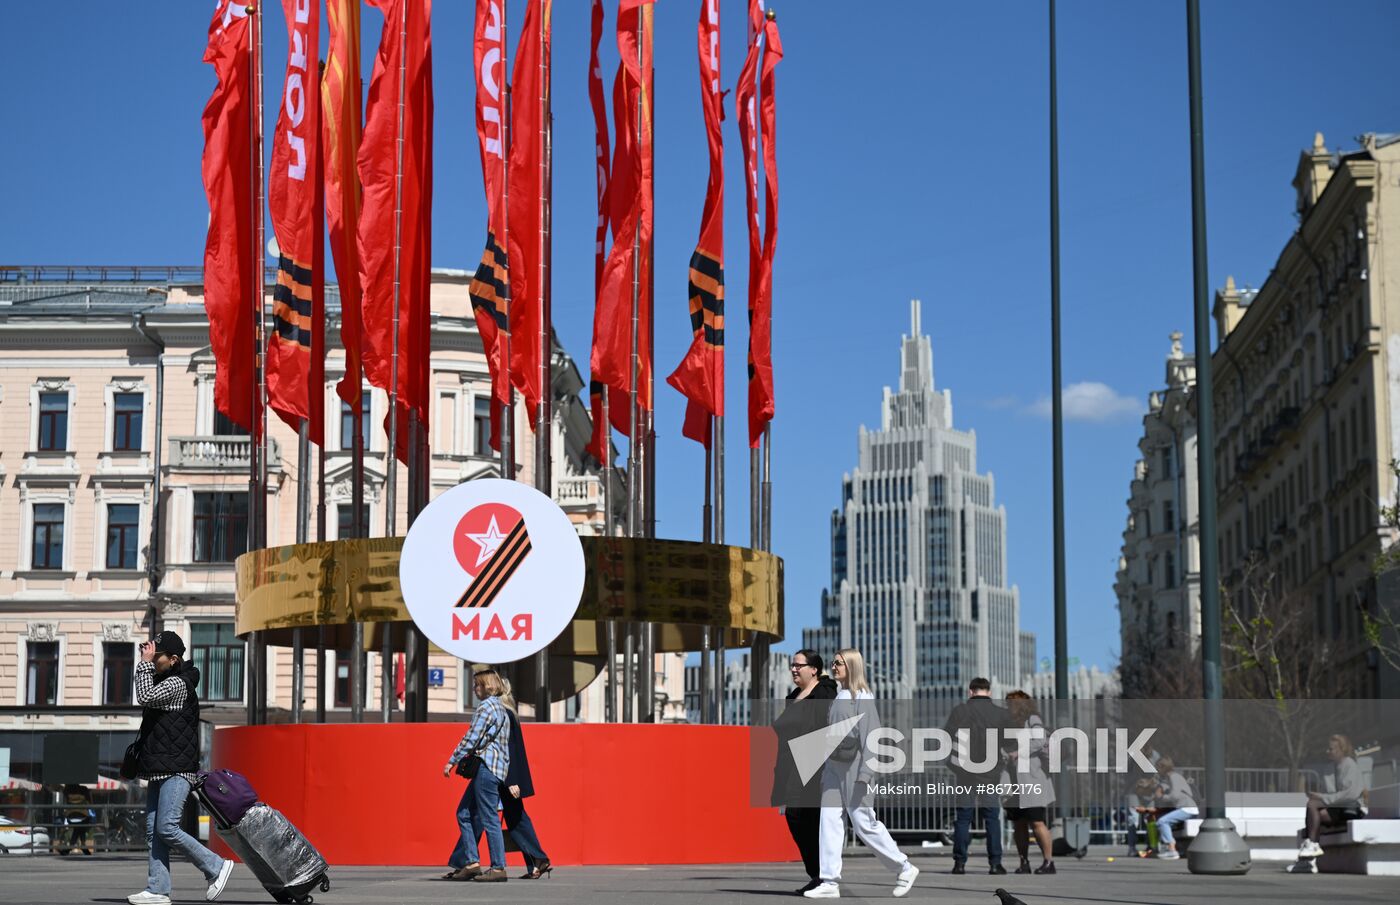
442, 668, 511, 883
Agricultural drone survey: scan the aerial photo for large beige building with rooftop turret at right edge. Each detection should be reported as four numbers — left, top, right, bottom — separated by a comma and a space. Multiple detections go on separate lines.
1211, 134, 1400, 695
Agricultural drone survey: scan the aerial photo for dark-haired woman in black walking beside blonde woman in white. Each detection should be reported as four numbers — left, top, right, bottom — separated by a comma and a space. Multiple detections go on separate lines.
770, 647, 837, 892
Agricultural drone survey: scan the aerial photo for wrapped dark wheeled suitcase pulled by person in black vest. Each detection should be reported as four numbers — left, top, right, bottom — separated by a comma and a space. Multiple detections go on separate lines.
214, 803, 330, 905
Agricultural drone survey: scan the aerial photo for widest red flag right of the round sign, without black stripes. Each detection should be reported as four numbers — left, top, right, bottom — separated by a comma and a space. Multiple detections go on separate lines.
589, 0, 652, 431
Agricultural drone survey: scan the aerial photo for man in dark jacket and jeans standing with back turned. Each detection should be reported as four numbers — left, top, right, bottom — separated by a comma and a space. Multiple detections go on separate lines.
944, 677, 1012, 874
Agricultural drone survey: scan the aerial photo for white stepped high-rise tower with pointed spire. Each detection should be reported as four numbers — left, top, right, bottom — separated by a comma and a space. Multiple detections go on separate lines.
802, 300, 1035, 702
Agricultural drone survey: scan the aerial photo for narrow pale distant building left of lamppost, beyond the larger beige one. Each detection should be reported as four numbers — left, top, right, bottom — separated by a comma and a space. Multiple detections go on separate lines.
1113, 333, 1201, 693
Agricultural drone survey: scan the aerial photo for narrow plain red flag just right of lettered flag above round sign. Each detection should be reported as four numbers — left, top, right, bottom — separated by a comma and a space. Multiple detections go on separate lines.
508, 0, 554, 429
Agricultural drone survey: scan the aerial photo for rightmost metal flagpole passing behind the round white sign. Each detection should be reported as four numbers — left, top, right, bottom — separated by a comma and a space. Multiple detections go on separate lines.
535, 0, 554, 723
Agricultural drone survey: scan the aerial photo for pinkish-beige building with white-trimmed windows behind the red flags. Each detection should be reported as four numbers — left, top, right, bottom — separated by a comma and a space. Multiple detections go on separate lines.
0, 268, 683, 767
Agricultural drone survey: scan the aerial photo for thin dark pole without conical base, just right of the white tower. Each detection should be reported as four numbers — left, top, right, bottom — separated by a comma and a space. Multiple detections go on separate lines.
1050, 0, 1070, 700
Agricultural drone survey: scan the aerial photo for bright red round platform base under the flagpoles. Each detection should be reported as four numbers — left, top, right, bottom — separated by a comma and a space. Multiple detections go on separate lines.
213, 723, 797, 866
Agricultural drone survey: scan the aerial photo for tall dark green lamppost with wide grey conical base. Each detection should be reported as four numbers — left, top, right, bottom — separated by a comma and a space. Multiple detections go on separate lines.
1186, 0, 1250, 874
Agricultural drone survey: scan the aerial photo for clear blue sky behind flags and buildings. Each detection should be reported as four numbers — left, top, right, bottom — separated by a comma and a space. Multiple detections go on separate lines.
0, 0, 1400, 665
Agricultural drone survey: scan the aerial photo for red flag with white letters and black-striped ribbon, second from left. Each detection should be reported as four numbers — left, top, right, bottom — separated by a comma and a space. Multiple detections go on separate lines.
267, 0, 322, 439
